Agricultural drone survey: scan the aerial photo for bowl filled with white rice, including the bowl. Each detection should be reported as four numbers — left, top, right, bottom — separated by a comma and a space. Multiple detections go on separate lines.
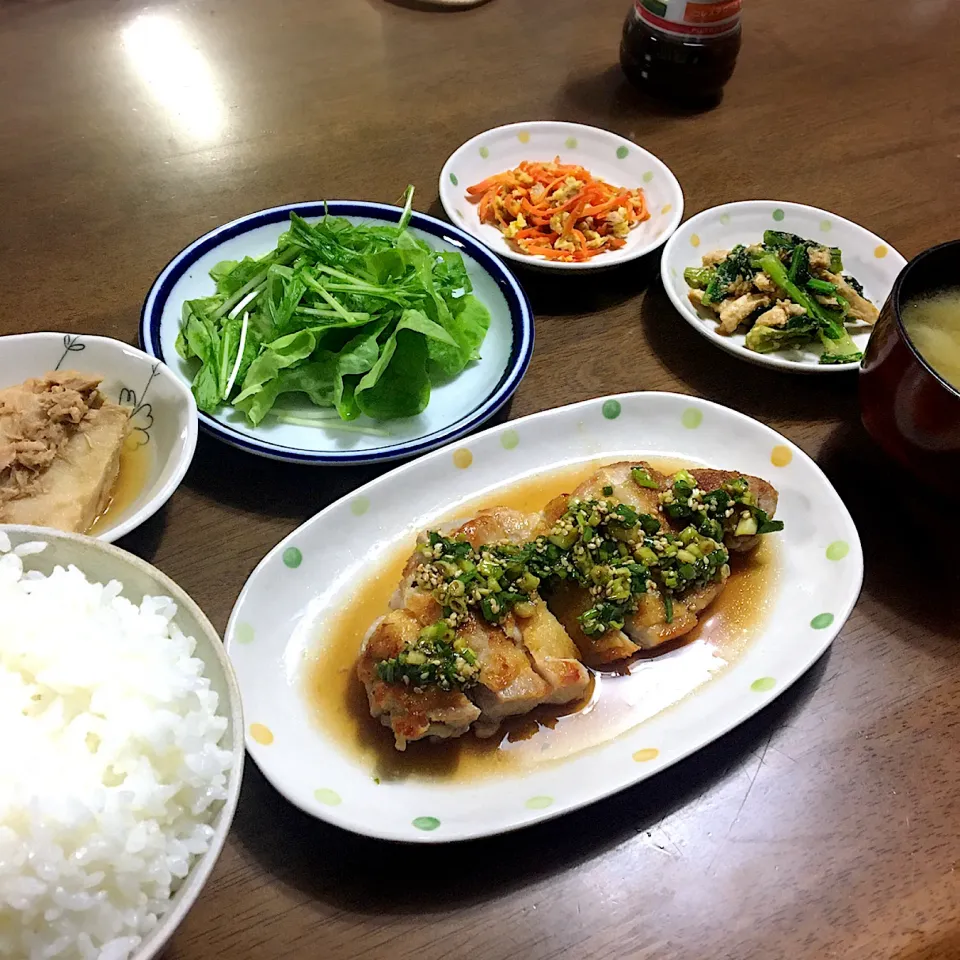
0, 526, 244, 960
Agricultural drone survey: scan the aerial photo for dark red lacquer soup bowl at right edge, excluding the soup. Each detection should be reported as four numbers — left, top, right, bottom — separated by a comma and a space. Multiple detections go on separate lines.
860, 240, 960, 493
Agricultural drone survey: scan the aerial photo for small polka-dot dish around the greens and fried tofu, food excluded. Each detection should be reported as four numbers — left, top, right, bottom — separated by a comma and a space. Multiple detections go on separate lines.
660, 200, 907, 373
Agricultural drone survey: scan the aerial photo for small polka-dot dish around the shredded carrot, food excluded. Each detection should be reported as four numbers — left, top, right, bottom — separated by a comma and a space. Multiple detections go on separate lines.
440, 120, 683, 271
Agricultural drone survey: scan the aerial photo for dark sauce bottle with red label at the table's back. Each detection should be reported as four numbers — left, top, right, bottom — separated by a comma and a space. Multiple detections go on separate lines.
620, 0, 741, 106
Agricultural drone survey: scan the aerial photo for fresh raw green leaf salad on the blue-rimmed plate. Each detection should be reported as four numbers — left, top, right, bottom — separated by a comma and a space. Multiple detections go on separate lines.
177, 187, 490, 432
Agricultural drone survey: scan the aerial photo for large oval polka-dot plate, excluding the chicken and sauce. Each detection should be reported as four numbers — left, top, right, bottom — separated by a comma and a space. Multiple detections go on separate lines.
226, 393, 863, 843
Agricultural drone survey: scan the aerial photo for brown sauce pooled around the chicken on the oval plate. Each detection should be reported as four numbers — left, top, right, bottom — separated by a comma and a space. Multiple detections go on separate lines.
303, 460, 778, 781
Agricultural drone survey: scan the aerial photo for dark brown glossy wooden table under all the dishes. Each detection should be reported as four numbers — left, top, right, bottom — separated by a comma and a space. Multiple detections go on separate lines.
0, 0, 960, 960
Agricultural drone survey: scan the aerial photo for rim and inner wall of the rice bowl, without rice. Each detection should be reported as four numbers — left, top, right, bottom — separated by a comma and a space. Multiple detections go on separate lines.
0, 526, 245, 960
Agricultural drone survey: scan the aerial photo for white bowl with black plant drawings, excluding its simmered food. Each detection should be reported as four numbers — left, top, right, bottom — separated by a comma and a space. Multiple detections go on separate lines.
0, 333, 197, 543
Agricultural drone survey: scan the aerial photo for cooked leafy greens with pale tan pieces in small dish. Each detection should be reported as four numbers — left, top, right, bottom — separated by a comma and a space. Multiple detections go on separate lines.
683, 230, 879, 363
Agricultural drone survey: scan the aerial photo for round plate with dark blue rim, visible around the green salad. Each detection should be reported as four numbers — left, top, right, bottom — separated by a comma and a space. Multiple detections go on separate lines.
140, 200, 533, 466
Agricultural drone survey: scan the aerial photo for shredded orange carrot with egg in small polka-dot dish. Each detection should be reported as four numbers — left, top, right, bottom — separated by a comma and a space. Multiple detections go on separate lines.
467, 157, 650, 263
